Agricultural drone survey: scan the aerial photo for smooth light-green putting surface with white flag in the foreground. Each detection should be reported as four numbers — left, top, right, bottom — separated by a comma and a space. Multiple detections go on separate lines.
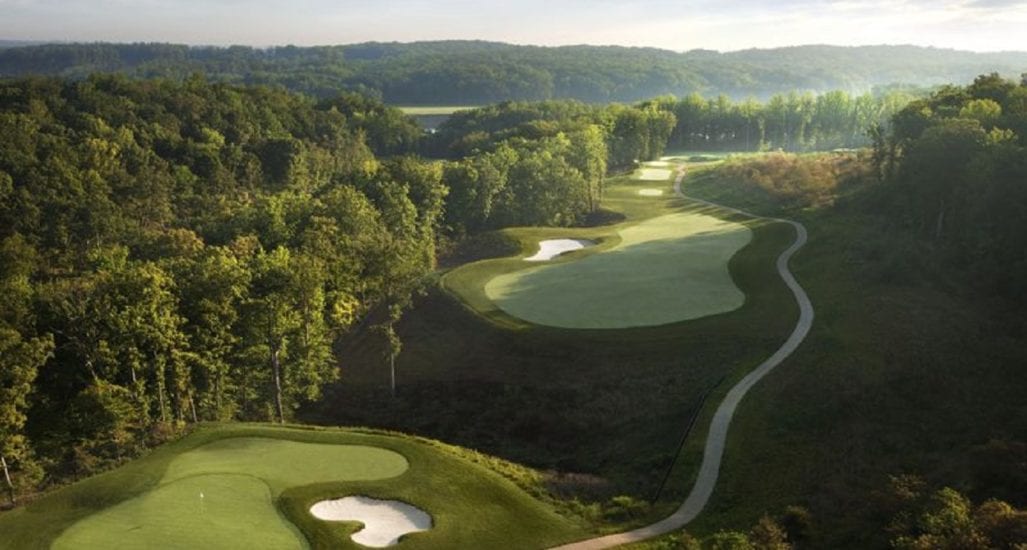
53, 437, 410, 549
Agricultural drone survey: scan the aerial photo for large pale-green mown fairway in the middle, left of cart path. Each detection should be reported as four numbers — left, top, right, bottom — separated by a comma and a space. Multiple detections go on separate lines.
485, 212, 752, 328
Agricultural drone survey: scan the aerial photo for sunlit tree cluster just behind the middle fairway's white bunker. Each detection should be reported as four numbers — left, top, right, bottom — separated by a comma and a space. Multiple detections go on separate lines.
439, 101, 675, 232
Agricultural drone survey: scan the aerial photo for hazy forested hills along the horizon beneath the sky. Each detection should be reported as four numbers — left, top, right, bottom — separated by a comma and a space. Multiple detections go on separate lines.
0, 41, 1027, 105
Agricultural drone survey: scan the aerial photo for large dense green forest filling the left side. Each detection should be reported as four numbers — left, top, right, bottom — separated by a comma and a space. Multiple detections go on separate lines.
0, 77, 446, 496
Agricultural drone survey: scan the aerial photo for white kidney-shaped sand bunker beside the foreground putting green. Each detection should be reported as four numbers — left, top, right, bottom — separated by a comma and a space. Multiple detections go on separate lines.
310, 497, 431, 548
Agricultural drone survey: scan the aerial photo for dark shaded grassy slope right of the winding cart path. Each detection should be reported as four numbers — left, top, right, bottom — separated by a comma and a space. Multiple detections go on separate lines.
640, 162, 1027, 549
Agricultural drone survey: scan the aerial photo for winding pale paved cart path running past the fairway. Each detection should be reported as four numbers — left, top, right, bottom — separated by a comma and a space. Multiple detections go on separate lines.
555, 169, 813, 550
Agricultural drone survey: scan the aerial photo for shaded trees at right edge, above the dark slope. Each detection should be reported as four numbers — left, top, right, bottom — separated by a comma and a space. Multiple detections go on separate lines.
873, 74, 1027, 304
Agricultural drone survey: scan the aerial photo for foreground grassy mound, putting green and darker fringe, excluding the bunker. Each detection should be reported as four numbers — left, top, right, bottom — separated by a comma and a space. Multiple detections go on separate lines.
0, 425, 581, 549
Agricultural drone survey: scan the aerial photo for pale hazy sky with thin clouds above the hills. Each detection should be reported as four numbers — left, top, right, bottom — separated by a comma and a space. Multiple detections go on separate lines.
6, 0, 1027, 51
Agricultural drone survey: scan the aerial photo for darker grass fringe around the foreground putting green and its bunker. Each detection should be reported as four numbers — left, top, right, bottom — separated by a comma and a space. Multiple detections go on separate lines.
0, 425, 580, 550
